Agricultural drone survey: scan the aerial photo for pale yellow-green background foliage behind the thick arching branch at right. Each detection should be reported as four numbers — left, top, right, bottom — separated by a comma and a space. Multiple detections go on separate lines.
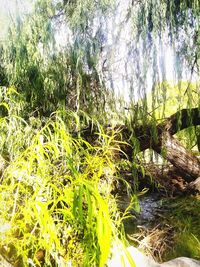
147, 81, 200, 152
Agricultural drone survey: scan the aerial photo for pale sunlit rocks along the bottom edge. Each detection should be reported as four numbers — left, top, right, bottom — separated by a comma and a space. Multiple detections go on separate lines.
107, 246, 200, 267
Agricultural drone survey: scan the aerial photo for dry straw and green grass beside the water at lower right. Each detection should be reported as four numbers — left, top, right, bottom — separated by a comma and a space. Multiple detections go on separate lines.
128, 196, 200, 262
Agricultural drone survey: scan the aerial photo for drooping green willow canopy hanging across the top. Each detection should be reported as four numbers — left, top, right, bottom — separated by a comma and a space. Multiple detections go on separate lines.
1, 0, 199, 113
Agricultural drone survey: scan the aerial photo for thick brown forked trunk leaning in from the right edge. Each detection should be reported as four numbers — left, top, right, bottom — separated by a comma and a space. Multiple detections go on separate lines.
81, 108, 200, 188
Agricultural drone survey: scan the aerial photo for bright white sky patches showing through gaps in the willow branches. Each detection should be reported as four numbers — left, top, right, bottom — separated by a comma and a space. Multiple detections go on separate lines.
0, 0, 195, 100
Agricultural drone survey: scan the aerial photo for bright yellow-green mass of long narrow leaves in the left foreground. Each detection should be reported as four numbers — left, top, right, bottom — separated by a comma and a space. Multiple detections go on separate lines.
0, 91, 136, 267
